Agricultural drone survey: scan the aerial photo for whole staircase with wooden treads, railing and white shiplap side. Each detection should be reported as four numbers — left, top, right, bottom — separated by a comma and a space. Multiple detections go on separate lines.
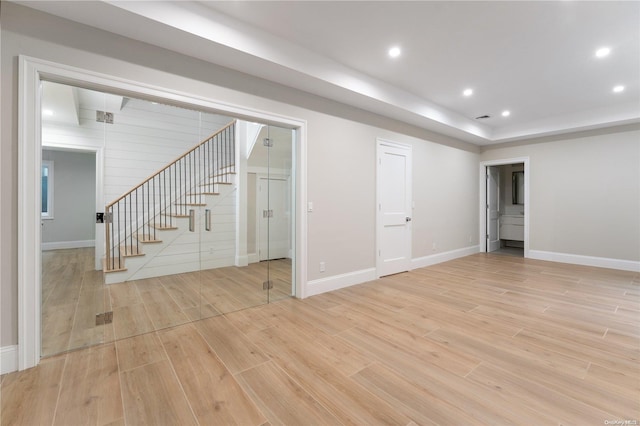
103, 121, 236, 284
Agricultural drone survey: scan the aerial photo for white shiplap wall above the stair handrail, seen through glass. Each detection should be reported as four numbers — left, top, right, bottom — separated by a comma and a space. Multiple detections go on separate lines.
42, 96, 232, 205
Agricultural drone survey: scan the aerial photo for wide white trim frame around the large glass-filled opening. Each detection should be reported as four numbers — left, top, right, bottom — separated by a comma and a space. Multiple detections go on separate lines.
17, 55, 307, 370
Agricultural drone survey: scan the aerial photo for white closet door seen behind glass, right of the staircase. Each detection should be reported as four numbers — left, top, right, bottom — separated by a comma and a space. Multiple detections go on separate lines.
258, 178, 290, 261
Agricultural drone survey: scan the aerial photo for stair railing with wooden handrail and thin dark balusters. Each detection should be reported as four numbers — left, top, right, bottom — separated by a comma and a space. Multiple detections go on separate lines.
104, 120, 237, 271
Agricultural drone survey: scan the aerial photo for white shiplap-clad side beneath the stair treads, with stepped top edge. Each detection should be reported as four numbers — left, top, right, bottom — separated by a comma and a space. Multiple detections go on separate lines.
105, 185, 237, 284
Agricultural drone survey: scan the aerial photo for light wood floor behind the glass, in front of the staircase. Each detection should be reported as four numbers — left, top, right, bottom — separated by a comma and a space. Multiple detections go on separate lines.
42, 248, 291, 356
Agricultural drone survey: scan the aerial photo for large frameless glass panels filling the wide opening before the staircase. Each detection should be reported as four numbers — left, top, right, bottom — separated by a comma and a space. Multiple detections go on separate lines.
41, 82, 295, 356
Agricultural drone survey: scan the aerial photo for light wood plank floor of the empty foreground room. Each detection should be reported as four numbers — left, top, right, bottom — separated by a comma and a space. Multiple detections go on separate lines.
1, 254, 640, 425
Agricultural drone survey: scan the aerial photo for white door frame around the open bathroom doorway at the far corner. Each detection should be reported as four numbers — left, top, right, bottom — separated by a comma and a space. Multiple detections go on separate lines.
478, 157, 531, 258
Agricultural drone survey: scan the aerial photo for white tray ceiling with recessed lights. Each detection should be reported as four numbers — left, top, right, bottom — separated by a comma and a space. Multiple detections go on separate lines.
19, 1, 640, 145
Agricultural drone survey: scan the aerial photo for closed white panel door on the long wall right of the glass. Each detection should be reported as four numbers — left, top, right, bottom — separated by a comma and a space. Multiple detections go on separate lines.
377, 141, 411, 276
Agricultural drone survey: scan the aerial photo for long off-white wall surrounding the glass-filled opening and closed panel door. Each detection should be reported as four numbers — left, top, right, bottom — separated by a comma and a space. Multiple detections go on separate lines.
0, 3, 479, 346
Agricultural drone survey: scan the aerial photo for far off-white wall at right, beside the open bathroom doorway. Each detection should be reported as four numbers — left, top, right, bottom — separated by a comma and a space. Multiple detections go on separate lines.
480, 125, 640, 264
